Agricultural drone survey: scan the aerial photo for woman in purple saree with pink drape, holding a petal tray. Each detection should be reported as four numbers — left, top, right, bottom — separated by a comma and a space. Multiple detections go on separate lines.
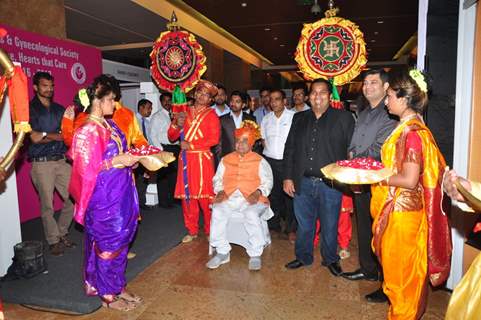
69, 77, 142, 311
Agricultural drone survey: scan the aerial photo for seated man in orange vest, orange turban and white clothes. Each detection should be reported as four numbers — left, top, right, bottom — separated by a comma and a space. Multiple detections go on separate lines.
207, 120, 273, 270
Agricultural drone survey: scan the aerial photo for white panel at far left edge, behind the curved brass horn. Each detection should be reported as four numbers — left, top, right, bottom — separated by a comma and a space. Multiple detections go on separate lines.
0, 97, 22, 276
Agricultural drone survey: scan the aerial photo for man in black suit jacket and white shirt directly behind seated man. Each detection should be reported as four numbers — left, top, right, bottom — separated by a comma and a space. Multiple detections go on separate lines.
216, 91, 256, 160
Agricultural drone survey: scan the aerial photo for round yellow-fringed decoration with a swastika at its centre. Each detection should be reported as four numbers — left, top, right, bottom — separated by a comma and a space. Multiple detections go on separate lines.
295, 17, 367, 85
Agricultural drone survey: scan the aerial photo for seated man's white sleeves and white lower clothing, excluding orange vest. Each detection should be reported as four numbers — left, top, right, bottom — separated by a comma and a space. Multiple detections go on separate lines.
210, 159, 273, 257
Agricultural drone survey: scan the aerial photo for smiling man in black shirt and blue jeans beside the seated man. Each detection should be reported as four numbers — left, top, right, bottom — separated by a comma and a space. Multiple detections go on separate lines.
283, 79, 354, 276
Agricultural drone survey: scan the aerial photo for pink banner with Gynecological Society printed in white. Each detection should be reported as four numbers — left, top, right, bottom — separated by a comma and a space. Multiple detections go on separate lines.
0, 24, 102, 222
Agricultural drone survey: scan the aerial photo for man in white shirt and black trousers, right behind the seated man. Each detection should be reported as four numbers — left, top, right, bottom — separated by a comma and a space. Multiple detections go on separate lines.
261, 89, 296, 233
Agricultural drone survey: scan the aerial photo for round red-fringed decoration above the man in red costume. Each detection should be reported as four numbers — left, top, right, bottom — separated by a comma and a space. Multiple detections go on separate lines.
150, 31, 207, 92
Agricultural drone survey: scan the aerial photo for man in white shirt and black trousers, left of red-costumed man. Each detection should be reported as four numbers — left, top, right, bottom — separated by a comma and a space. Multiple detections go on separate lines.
149, 93, 180, 208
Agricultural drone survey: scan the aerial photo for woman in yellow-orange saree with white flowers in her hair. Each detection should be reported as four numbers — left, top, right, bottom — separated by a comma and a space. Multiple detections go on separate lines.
371, 70, 451, 320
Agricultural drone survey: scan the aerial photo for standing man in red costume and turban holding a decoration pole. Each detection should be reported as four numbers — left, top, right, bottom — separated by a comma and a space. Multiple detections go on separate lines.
167, 80, 220, 242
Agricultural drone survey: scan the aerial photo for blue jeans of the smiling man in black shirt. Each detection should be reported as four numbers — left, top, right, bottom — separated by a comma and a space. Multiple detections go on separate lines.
294, 177, 342, 266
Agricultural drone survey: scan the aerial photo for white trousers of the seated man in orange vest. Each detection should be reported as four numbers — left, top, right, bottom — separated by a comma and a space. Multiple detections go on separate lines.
210, 191, 271, 257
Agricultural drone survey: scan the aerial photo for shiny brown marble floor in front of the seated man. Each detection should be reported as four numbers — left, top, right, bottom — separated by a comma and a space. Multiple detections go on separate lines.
4, 232, 450, 320
